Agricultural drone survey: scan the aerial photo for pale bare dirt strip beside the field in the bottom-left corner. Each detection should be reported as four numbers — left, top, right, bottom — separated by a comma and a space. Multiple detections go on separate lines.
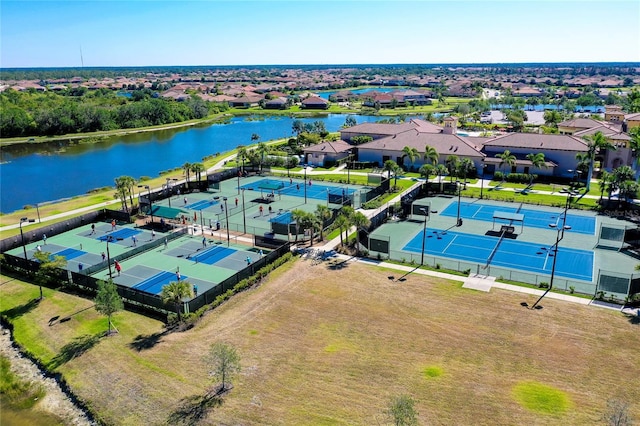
0, 326, 96, 426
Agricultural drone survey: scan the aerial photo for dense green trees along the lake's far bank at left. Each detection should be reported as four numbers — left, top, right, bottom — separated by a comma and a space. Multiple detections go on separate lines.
0, 88, 227, 138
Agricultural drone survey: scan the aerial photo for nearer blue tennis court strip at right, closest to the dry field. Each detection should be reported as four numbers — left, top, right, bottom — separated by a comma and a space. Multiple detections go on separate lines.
403, 229, 593, 281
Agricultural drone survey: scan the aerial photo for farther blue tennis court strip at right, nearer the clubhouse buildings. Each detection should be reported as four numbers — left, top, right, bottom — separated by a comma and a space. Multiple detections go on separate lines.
440, 201, 596, 235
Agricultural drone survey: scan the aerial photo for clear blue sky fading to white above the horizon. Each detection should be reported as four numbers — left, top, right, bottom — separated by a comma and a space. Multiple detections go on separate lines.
0, 0, 640, 68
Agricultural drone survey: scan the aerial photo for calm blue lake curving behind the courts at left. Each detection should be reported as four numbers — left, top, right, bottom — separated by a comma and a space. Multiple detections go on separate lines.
0, 114, 390, 213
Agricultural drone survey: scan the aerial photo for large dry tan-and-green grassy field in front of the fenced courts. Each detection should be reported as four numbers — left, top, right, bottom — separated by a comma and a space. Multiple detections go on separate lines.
0, 260, 640, 425
